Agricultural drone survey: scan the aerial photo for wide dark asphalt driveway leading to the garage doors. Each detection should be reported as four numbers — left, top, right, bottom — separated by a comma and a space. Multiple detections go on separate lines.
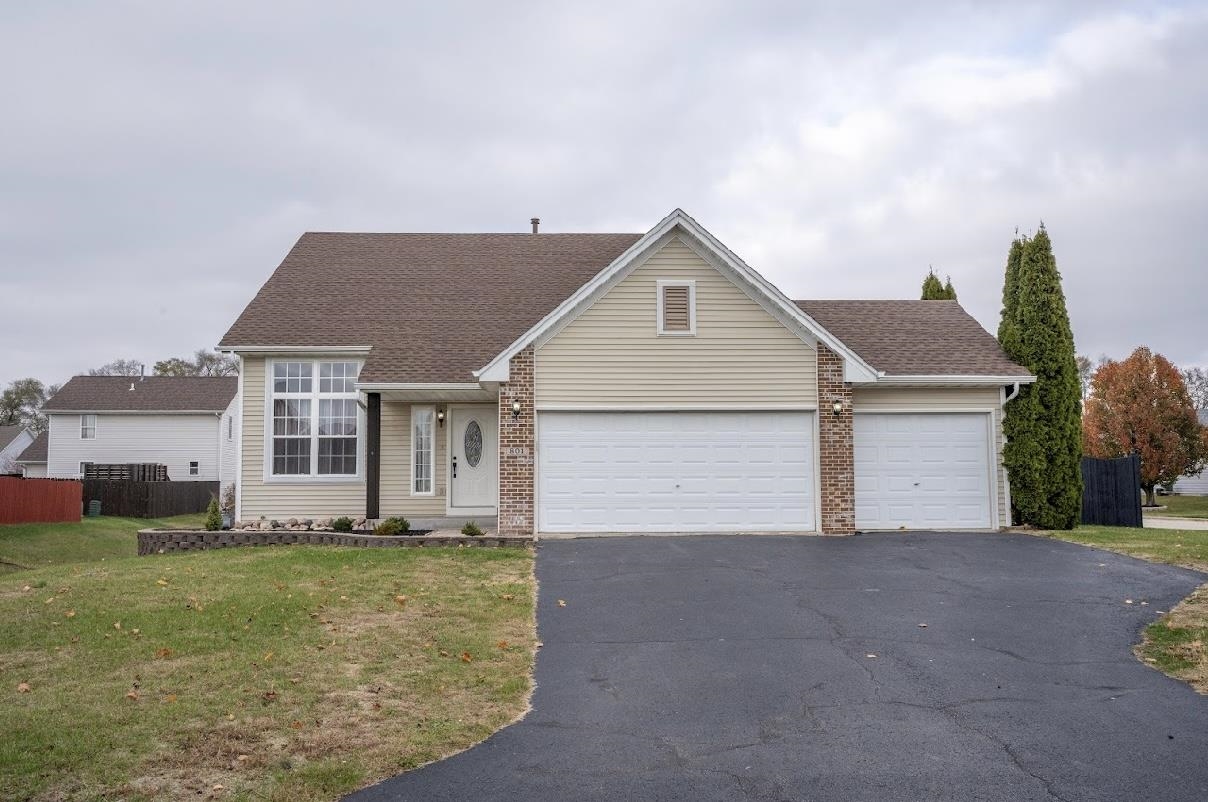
350, 534, 1208, 802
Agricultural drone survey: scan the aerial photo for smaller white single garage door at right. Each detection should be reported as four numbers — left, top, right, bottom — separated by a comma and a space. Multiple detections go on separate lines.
854, 412, 993, 529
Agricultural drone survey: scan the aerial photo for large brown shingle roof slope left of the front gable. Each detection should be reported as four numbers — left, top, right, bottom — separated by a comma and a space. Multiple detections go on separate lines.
221, 233, 640, 382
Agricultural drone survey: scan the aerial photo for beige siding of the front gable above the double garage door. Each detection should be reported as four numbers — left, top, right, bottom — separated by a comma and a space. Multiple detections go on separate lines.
535, 239, 818, 408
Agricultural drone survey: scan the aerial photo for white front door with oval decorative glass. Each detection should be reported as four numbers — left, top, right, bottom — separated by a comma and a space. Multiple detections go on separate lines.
448, 405, 499, 515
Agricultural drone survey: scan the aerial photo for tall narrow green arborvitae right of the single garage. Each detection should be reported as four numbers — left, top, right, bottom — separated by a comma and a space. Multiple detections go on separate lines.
999, 225, 1082, 529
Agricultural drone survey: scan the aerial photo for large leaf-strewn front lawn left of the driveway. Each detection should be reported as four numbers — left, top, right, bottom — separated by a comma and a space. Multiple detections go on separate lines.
0, 536, 535, 802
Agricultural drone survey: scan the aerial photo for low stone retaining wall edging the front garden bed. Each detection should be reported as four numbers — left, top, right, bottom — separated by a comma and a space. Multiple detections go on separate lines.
139, 529, 533, 554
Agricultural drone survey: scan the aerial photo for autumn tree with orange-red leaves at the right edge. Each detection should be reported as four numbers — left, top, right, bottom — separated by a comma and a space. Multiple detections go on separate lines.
1082, 348, 1208, 506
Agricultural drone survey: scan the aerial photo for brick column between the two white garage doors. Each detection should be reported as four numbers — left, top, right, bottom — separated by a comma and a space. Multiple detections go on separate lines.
818, 343, 855, 535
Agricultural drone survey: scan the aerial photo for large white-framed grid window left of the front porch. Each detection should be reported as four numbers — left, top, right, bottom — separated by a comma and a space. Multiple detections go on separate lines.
265, 360, 360, 476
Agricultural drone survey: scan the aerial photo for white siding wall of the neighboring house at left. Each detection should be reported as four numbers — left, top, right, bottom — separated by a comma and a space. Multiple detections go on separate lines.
47, 412, 219, 482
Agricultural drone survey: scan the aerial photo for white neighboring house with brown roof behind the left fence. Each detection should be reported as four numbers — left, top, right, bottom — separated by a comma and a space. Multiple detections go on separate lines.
42, 376, 239, 484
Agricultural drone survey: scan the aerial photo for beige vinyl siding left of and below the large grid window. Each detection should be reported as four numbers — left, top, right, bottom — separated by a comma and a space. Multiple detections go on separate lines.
239, 356, 365, 521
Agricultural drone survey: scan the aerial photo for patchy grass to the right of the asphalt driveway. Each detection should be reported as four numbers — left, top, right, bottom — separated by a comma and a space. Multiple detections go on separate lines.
1044, 526, 1208, 693
